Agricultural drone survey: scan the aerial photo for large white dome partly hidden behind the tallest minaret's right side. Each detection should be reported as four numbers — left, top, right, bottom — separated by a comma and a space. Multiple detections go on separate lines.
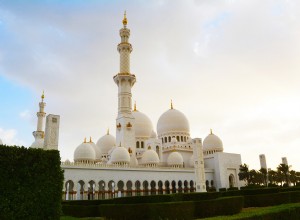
132, 110, 153, 138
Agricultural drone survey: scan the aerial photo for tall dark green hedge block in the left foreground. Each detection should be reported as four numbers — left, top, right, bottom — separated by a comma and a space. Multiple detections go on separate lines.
0, 145, 63, 219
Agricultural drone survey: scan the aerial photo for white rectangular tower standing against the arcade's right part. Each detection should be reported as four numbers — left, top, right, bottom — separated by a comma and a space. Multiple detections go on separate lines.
193, 138, 206, 192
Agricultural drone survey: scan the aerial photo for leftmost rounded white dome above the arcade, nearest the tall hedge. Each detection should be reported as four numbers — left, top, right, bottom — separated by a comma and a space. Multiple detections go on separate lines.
74, 143, 96, 162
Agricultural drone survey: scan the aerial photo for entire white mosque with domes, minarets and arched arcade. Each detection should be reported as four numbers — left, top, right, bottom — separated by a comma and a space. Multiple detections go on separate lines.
1, 14, 243, 200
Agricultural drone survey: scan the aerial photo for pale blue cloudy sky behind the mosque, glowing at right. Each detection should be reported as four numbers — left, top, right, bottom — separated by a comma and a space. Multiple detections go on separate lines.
0, 0, 300, 171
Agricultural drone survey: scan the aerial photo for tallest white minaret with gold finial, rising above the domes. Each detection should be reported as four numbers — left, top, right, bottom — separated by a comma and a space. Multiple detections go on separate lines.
114, 12, 136, 161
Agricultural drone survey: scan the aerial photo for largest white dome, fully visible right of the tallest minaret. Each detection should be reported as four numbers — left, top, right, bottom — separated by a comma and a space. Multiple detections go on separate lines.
157, 108, 190, 136
